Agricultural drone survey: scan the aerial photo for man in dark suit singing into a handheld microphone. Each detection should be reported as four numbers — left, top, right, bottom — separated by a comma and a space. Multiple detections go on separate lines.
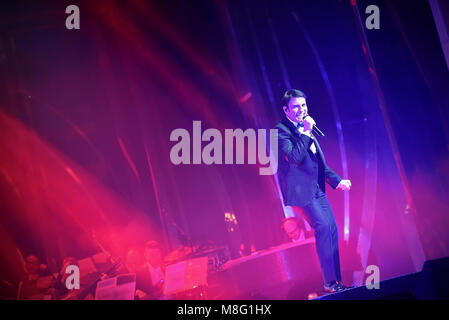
275, 89, 351, 292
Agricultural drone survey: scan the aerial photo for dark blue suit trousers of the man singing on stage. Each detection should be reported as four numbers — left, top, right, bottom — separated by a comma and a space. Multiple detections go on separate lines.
294, 185, 341, 284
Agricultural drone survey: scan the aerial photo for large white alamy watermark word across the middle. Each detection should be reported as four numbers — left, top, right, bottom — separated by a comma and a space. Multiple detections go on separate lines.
170, 121, 278, 175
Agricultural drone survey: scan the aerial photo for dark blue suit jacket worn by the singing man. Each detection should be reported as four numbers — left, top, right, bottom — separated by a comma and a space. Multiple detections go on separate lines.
275, 118, 341, 207
